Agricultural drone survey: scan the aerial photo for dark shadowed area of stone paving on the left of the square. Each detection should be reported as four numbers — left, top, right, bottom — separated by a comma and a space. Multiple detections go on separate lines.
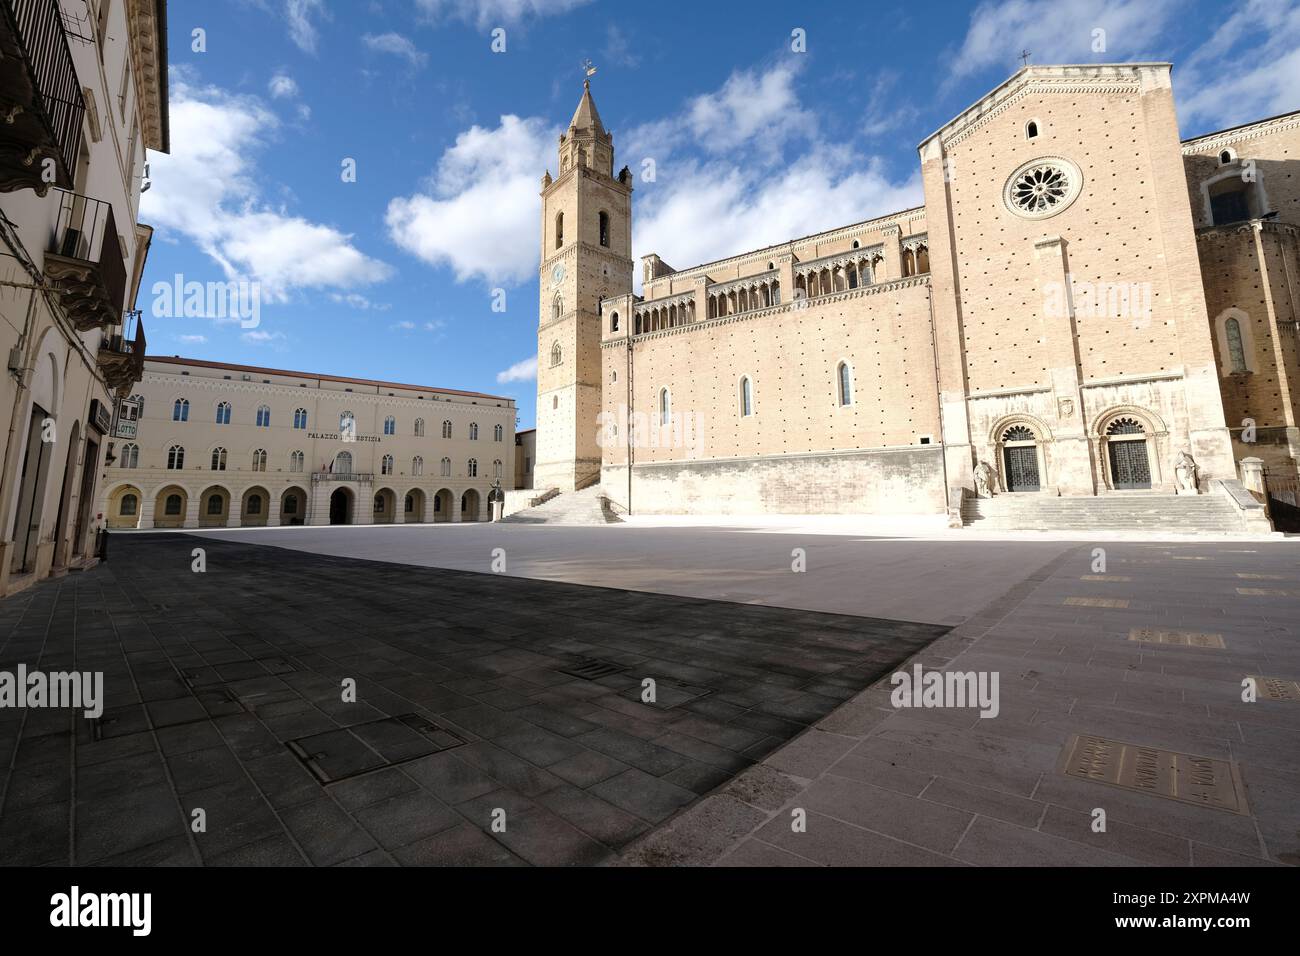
0, 535, 946, 866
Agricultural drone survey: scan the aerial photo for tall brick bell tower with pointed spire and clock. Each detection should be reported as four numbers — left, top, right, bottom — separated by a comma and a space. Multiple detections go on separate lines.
533, 79, 632, 492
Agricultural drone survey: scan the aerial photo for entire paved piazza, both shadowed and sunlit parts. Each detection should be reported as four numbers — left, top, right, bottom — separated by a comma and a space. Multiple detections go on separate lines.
0, 524, 1300, 866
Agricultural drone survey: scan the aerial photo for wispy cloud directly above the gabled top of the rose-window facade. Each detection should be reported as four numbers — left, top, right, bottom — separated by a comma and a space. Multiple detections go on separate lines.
945, 0, 1182, 82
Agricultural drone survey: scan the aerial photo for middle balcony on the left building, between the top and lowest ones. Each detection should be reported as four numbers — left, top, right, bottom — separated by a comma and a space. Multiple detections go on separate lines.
45, 191, 126, 332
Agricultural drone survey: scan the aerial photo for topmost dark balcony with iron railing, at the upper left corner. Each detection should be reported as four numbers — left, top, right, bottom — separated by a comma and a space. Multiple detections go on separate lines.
0, 0, 86, 195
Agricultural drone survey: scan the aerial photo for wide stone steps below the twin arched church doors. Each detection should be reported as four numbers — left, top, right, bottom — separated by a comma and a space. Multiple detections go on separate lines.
962, 493, 1252, 535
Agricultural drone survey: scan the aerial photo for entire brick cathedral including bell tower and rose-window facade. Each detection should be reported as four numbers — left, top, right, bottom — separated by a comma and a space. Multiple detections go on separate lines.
536, 64, 1300, 515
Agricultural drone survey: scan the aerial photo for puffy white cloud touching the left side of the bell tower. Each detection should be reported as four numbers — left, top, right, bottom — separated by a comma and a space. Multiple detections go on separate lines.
385, 116, 558, 282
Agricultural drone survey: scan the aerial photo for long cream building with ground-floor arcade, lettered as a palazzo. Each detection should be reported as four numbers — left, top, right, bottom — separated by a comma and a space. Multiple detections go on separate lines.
100, 356, 516, 528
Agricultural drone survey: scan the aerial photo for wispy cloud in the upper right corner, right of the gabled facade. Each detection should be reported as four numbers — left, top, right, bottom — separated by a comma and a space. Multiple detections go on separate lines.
1174, 0, 1300, 129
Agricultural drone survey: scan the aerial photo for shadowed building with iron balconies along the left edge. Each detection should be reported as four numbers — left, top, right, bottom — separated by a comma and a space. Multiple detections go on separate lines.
0, 0, 169, 596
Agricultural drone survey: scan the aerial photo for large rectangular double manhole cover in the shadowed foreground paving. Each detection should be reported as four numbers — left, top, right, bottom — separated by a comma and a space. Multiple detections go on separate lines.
287, 714, 465, 783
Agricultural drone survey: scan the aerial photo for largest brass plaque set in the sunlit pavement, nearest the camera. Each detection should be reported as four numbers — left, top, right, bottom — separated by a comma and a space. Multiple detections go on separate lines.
1062, 734, 1251, 816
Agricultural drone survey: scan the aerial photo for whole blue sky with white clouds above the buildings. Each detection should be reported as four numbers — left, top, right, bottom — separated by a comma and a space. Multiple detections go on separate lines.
138, 0, 1300, 428
